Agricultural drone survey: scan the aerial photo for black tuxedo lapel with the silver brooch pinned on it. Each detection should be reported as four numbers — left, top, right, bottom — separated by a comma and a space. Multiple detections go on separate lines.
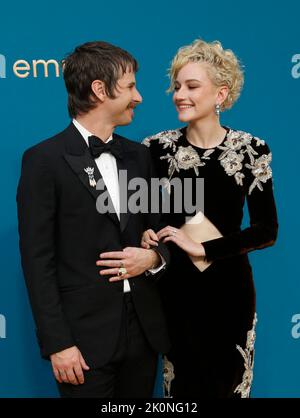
64, 123, 120, 225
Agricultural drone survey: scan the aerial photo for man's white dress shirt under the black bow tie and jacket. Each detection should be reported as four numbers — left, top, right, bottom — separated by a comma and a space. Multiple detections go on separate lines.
73, 119, 166, 293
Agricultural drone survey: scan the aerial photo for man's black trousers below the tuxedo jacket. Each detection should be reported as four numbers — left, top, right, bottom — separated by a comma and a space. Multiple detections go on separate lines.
58, 293, 158, 398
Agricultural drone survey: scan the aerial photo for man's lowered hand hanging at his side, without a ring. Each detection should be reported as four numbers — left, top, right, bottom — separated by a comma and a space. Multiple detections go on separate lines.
50, 345, 89, 385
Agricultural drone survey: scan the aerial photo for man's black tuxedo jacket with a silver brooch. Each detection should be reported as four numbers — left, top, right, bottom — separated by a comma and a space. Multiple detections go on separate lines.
17, 124, 169, 367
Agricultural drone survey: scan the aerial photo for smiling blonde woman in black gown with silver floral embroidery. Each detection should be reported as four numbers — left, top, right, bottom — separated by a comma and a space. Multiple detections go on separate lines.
142, 40, 278, 398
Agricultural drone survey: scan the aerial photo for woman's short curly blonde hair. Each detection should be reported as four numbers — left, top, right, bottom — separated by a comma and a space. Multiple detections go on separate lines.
168, 39, 244, 110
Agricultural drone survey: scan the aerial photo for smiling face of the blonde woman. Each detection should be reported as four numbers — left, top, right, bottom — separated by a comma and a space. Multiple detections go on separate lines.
173, 62, 219, 123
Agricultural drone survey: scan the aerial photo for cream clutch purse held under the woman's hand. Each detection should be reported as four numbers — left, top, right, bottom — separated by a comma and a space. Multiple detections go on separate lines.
180, 212, 223, 271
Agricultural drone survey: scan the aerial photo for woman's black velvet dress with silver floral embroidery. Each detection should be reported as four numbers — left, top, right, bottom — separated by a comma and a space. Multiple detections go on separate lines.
144, 128, 278, 398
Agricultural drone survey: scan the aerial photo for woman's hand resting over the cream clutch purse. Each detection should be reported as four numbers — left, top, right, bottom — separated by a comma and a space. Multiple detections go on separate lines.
157, 225, 205, 257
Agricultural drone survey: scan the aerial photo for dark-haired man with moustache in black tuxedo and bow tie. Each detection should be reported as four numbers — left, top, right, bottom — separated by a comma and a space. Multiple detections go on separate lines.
17, 42, 169, 398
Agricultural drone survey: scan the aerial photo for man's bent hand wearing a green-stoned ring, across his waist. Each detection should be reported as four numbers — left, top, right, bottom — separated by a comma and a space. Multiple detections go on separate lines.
96, 247, 160, 282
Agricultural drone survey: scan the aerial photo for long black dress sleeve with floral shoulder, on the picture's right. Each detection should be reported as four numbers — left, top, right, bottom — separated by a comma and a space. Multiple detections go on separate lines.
202, 138, 278, 261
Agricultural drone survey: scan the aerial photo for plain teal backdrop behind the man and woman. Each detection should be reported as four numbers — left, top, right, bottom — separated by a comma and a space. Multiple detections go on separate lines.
0, 0, 300, 397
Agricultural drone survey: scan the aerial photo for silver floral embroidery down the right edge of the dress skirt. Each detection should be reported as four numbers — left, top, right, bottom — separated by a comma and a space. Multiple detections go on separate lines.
234, 313, 257, 398
